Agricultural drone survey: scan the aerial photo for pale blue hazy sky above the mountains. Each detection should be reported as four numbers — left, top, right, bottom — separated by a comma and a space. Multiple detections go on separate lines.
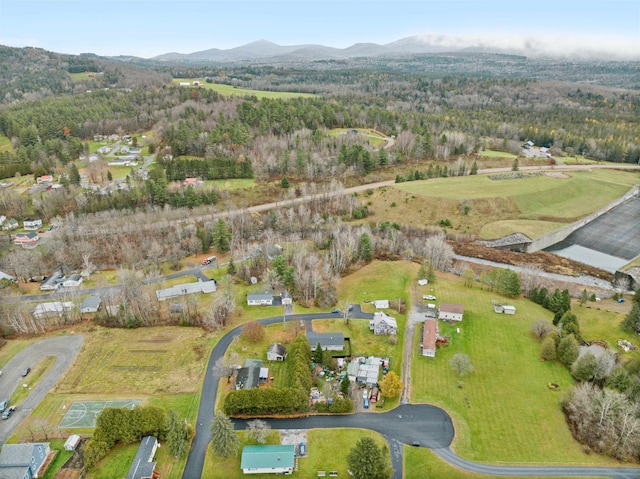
0, 0, 640, 59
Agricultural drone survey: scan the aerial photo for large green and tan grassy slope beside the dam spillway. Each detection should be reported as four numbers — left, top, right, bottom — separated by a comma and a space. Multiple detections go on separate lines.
370, 168, 638, 239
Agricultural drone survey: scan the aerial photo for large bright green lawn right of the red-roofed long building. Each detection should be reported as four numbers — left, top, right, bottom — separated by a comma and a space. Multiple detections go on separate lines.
411, 275, 613, 464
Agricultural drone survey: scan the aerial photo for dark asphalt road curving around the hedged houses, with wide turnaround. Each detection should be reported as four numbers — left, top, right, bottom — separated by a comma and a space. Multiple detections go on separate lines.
182, 316, 640, 479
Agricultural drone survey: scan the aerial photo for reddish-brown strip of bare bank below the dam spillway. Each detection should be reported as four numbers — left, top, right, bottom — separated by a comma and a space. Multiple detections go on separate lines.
451, 243, 611, 281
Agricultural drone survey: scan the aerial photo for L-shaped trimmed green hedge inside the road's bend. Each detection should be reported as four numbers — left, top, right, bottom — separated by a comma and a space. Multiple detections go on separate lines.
224, 334, 311, 416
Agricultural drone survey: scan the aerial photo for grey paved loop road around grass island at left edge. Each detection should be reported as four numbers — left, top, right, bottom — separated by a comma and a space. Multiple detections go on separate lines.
0, 336, 84, 445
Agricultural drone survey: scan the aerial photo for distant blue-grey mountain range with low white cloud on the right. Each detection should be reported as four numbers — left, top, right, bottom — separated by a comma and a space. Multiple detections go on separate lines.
150, 34, 638, 62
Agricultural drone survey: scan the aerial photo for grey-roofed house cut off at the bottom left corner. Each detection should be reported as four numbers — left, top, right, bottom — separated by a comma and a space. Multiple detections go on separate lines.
0, 442, 51, 479
